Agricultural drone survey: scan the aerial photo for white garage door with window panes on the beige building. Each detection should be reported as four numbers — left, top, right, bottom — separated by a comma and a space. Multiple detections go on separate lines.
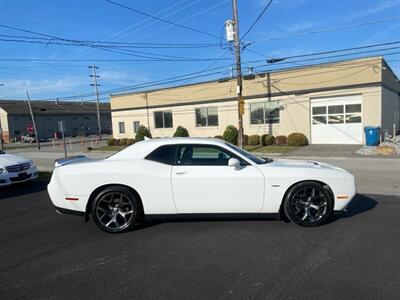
311, 95, 362, 144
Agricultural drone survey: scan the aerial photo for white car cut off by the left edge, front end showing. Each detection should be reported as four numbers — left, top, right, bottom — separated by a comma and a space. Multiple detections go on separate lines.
0, 150, 38, 187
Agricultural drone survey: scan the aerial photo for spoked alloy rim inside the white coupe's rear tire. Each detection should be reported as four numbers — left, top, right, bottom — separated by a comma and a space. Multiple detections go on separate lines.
96, 192, 136, 231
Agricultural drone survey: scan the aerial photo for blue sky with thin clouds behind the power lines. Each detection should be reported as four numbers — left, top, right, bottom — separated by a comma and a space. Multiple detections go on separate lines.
0, 0, 400, 100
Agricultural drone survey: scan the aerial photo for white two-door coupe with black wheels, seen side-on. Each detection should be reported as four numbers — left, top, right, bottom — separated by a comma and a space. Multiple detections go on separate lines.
48, 138, 356, 232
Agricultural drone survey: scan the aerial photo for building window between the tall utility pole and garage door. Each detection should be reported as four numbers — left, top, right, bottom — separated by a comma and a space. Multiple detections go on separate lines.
250, 101, 280, 124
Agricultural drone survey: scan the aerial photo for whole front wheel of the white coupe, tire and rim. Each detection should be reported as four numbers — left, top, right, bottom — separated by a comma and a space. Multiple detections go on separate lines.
283, 181, 334, 227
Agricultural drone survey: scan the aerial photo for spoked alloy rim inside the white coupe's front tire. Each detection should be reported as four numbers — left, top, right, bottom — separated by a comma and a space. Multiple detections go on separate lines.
290, 187, 328, 224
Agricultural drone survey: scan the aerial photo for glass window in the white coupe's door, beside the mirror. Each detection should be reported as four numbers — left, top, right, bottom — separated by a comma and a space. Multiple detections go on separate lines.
176, 144, 234, 166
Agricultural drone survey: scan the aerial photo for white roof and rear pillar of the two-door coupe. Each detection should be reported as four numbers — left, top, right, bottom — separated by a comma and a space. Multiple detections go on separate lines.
108, 137, 225, 160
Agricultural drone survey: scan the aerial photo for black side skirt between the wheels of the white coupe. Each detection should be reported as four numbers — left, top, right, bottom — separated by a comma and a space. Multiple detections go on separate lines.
145, 213, 280, 221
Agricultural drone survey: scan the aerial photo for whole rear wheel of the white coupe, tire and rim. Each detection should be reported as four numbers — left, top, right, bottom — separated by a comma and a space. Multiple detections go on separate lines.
91, 186, 141, 233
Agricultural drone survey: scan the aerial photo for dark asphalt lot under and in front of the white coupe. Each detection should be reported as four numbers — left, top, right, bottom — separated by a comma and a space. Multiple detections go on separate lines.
0, 181, 400, 299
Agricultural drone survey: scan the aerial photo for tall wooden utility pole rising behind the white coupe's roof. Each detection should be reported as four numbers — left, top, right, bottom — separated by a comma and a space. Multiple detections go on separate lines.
232, 0, 244, 147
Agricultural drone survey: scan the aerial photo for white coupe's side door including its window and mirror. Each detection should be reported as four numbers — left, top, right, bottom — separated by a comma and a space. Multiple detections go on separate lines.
171, 144, 264, 213
